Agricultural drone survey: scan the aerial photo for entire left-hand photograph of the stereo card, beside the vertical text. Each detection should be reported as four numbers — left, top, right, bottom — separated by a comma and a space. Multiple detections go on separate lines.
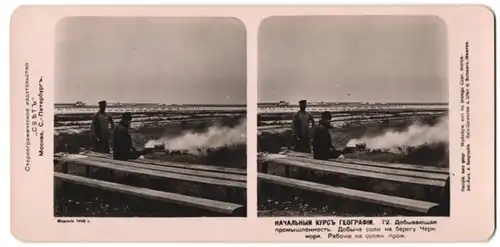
54, 17, 247, 217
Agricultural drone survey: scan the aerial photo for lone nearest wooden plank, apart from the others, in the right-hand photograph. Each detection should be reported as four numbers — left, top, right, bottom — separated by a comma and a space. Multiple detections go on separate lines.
258, 173, 437, 213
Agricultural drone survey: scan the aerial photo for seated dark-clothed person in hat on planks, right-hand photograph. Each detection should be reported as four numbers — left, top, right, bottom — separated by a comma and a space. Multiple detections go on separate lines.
313, 111, 342, 160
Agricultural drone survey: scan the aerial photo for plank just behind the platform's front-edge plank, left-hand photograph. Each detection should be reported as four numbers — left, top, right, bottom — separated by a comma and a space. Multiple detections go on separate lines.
88, 156, 247, 182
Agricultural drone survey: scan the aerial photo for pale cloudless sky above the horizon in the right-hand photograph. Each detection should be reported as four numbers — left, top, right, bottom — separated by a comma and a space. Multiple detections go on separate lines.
258, 16, 448, 103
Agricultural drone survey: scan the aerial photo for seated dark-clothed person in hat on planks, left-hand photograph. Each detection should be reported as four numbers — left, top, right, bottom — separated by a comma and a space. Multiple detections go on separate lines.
113, 112, 152, 160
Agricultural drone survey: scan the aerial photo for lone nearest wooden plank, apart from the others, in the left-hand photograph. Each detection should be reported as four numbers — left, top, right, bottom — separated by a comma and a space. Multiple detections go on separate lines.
54, 172, 243, 214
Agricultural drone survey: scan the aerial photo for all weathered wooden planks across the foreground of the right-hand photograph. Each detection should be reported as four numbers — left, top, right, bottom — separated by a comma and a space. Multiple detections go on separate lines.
258, 151, 449, 214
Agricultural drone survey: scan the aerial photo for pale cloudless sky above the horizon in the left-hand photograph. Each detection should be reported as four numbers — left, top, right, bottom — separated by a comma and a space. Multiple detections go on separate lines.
55, 17, 247, 104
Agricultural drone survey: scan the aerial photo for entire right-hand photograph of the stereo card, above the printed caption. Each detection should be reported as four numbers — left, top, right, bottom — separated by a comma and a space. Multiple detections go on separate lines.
257, 15, 450, 217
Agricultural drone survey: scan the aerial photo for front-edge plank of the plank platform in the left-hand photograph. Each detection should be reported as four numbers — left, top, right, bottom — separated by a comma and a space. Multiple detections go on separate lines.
54, 157, 246, 188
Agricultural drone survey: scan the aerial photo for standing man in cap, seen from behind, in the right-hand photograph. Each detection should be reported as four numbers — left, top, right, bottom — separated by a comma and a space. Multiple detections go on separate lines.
292, 100, 314, 153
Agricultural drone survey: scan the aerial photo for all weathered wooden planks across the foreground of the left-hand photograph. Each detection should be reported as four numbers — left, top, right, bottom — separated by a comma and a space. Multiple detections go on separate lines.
54, 153, 247, 217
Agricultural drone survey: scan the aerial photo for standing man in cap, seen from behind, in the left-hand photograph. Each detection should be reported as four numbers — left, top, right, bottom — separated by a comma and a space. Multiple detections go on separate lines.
90, 100, 115, 153
